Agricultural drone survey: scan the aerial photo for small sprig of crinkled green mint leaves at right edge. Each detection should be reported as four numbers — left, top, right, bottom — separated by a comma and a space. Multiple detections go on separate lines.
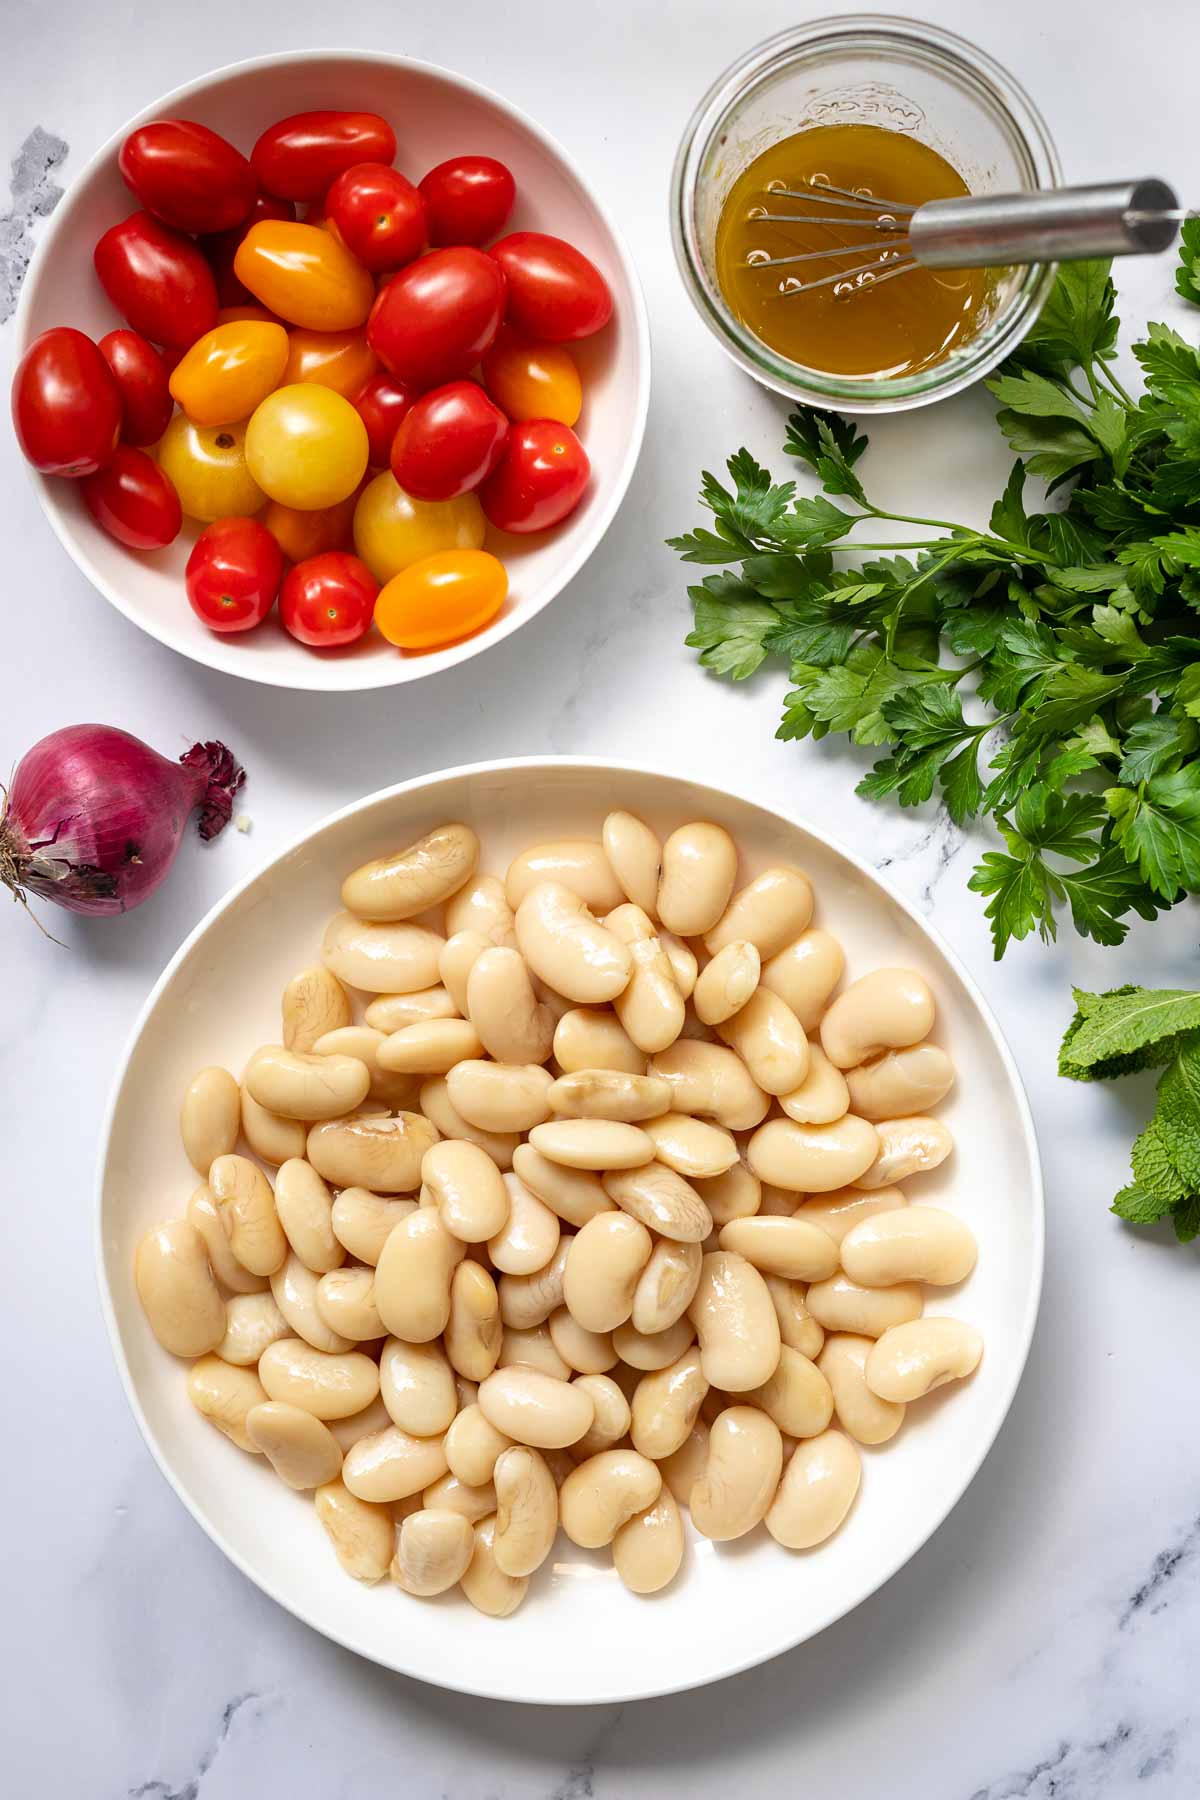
1058, 988, 1200, 1244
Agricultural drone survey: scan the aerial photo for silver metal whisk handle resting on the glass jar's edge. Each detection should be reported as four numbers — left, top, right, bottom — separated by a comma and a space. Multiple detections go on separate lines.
909, 180, 1180, 268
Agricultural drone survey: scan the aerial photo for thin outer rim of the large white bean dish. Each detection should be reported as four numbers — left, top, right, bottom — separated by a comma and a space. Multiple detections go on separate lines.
94, 756, 1045, 1706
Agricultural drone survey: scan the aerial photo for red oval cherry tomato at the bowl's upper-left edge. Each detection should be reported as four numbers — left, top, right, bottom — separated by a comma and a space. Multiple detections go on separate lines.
117, 119, 257, 232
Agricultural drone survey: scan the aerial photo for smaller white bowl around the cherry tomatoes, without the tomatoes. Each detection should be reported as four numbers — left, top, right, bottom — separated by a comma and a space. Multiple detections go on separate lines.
16, 50, 649, 693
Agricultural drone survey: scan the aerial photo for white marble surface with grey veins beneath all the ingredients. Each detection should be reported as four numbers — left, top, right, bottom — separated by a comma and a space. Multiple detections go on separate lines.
0, 0, 1200, 1800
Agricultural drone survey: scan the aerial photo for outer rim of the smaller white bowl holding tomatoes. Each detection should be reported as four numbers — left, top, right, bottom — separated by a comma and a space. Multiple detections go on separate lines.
13, 47, 651, 693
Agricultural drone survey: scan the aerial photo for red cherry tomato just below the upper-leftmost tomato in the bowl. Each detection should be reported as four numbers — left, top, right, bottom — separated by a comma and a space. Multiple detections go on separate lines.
94, 212, 216, 347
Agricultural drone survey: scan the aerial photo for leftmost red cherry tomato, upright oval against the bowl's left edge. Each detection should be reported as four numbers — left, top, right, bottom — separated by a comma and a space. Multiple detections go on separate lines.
13, 326, 121, 475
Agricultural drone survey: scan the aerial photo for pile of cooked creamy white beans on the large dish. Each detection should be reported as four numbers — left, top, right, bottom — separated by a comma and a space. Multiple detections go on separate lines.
135, 812, 982, 1616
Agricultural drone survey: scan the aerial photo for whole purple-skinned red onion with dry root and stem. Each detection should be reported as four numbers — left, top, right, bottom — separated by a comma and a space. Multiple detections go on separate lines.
0, 725, 246, 914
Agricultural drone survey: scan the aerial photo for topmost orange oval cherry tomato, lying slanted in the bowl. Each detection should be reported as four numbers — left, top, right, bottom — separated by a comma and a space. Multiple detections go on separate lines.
234, 220, 374, 331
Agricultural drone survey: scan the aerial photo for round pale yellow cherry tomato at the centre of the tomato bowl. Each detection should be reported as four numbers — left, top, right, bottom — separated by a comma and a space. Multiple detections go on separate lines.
246, 382, 371, 511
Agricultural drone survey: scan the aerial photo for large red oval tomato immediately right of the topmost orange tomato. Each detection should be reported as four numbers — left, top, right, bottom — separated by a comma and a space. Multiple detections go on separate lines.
367, 245, 504, 387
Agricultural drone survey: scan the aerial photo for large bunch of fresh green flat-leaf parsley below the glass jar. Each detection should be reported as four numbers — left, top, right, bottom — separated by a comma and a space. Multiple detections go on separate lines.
667, 253, 1200, 958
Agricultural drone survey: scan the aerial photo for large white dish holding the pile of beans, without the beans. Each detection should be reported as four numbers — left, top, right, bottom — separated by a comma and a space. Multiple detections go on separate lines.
99, 758, 1043, 1703
